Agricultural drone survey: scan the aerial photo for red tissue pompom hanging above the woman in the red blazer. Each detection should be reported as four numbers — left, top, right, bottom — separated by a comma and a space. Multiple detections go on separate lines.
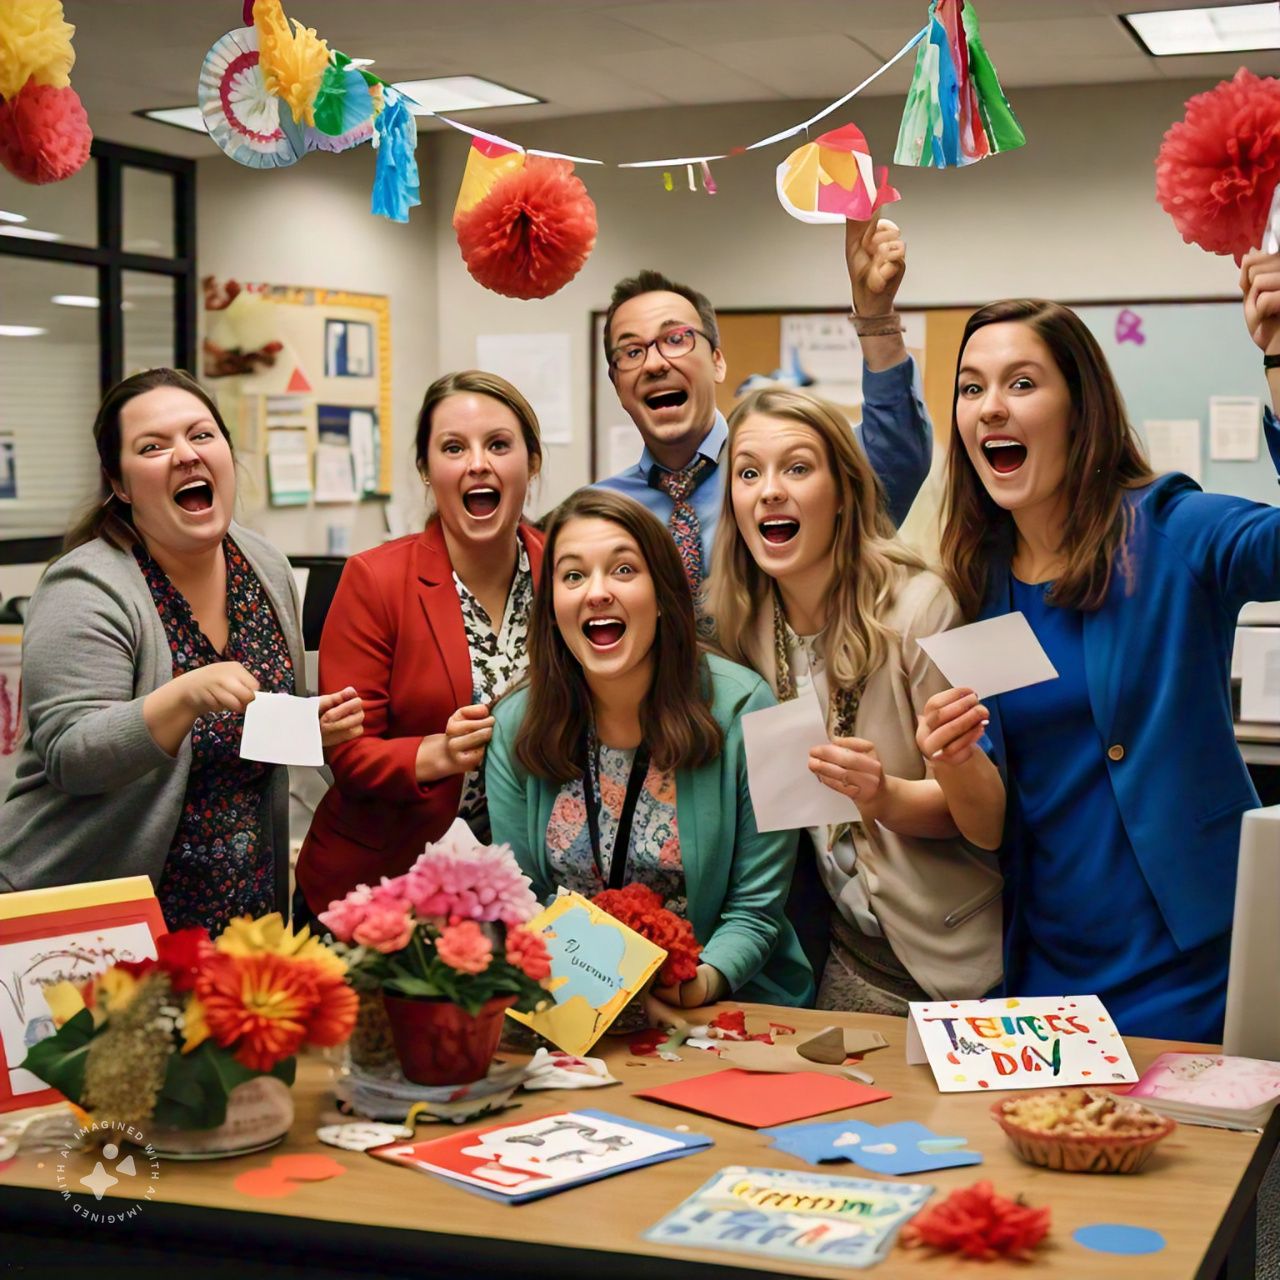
453, 156, 595, 298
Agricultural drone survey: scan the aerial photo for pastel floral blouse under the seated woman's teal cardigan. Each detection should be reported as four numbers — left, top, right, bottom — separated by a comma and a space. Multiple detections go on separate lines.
547, 745, 689, 916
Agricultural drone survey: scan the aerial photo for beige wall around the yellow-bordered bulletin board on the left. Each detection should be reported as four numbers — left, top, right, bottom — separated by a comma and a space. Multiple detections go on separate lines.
196, 146, 436, 554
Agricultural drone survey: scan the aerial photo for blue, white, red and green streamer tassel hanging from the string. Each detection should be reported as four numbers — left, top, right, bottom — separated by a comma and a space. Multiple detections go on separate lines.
893, 0, 1027, 169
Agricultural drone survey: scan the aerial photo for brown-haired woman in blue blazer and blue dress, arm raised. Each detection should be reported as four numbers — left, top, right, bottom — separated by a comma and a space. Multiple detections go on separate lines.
941, 253, 1280, 1041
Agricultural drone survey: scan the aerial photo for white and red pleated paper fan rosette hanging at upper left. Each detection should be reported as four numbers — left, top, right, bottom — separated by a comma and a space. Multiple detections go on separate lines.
197, 27, 306, 169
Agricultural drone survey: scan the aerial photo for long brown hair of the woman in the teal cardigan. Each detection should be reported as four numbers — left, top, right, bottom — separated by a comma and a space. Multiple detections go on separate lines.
515, 489, 724, 782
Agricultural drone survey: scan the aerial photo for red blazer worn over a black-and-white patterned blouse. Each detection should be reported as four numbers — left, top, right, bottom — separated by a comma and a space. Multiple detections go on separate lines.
297, 520, 543, 911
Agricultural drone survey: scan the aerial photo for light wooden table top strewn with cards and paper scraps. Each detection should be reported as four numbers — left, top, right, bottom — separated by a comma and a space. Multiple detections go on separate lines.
0, 1005, 1280, 1280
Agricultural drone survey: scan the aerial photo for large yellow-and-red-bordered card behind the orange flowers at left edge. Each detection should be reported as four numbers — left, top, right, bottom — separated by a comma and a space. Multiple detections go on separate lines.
0, 876, 168, 1111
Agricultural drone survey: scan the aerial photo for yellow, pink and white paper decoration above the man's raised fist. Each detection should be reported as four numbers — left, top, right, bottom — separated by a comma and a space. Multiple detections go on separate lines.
777, 124, 902, 224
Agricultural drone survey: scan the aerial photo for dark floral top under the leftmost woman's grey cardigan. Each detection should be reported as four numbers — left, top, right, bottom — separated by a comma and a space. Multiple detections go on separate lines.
133, 536, 293, 936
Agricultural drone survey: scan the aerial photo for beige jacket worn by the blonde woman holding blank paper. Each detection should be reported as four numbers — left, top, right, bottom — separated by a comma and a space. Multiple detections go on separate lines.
744, 571, 1002, 1000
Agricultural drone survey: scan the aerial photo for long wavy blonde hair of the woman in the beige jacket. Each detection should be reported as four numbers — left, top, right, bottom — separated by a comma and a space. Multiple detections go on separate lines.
705, 388, 925, 689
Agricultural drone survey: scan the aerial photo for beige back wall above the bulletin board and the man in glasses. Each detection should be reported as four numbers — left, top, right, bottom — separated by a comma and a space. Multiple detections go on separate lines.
424, 82, 1249, 509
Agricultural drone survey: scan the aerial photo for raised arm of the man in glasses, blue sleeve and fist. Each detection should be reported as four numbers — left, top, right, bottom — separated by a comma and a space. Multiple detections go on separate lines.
845, 218, 933, 525
